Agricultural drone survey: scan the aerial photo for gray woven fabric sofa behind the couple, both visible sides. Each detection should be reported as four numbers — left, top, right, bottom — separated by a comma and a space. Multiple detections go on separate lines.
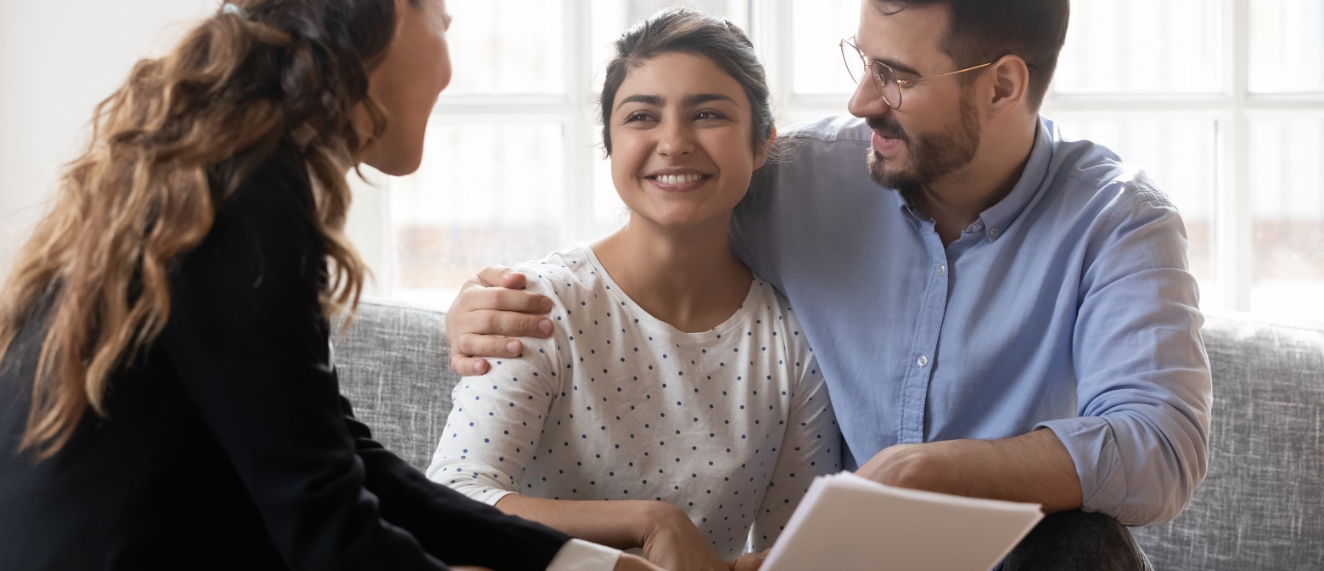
335, 302, 1324, 570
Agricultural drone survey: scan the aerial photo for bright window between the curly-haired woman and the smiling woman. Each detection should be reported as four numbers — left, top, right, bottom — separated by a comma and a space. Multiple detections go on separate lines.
350, 0, 753, 307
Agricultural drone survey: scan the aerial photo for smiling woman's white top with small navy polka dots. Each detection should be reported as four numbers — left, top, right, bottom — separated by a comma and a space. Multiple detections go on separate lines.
428, 245, 841, 559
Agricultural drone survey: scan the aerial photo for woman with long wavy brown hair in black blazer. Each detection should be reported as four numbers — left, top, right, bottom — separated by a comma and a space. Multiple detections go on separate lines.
0, 0, 655, 570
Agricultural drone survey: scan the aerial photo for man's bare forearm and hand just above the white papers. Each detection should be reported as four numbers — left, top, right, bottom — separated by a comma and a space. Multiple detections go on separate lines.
855, 431, 1083, 514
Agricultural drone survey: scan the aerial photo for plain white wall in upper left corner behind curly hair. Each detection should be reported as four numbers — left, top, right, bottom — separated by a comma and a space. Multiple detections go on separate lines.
0, 0, 218, 276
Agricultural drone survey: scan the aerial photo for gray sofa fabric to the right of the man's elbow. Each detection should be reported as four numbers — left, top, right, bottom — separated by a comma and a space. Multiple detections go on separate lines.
1132, 317, 1324, 570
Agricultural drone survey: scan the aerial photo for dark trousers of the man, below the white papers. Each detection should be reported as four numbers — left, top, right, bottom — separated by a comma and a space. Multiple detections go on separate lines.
1001, 510, 1153, 571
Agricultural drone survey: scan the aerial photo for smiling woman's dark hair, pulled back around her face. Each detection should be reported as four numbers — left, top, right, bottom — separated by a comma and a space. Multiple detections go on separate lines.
600, 8, 773, 155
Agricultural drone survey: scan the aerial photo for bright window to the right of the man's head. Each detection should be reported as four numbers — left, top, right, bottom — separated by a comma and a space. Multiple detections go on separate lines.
1045, 0, 1324, 318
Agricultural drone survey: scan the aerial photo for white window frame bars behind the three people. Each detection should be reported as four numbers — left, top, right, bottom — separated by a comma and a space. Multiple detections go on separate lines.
350, 0, 1324, 311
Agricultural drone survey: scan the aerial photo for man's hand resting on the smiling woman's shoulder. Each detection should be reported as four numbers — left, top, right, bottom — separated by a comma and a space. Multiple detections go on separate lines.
446, 266, 552, 376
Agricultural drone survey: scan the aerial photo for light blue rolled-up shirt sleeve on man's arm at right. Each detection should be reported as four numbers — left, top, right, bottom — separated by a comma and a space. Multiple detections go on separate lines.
1037, 189, 1213, 526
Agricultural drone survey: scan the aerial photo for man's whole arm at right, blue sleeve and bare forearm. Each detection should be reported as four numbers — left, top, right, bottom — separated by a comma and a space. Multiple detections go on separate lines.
861, 187, 1213, 526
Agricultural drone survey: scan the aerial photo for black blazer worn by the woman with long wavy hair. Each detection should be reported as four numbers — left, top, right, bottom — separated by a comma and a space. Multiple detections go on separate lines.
0, 151, 569, 571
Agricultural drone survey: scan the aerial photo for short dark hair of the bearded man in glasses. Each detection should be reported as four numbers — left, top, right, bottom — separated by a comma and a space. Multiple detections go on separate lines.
874, 0, 1071, 110
